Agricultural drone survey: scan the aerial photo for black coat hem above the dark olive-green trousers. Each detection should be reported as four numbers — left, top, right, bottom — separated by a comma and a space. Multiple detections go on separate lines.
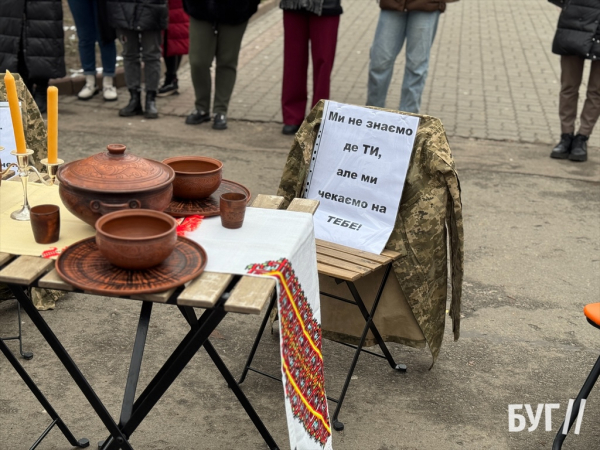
183, 0, 260, 25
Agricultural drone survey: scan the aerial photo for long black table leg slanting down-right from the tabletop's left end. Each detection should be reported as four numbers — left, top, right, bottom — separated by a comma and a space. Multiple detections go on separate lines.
8, 284, 133, 450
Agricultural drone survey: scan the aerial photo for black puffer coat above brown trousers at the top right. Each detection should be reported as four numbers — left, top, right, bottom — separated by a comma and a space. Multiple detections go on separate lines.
552, 0, 600, 61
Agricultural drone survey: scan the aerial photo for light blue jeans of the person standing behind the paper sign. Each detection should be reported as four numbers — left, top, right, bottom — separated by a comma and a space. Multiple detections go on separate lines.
367, 10, 440, 113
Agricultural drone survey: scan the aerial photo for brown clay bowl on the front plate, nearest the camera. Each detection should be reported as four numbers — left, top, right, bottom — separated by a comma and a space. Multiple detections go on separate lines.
96, 209, 177, 270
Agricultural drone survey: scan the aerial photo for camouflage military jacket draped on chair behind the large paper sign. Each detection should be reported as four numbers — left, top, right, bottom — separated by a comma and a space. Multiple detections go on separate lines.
278, 101, 464, 361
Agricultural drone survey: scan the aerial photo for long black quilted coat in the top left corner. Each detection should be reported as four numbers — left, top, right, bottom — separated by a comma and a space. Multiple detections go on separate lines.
0, 0, 66, 80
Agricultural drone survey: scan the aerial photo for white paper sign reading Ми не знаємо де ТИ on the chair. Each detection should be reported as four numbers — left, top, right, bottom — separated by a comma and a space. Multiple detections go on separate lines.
304, 101, 419, 254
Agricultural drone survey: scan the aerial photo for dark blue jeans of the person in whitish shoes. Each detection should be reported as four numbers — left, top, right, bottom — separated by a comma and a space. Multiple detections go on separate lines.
69, 0, 117, 77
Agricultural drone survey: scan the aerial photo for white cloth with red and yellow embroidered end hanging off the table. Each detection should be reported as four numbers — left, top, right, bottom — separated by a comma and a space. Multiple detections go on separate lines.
185, 208, 332, 450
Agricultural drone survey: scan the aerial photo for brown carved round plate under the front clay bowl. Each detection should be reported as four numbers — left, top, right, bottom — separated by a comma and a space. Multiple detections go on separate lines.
56, 236, 207, 296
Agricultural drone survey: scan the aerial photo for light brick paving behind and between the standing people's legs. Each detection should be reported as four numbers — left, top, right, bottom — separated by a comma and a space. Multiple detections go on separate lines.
63, 0, 600, 147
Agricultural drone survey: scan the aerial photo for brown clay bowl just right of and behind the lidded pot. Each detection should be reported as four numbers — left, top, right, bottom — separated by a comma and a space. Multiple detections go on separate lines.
163, 156, 223, 200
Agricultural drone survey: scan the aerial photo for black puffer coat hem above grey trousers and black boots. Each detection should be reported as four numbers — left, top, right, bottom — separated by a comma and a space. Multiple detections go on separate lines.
108, 0, 169, 31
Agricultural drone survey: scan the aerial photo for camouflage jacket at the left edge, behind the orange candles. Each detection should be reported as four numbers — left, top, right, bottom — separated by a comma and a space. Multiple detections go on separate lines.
0, 73, 47, 170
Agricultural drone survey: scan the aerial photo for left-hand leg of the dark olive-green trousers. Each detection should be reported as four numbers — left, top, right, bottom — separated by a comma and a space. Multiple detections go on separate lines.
189, 17, 217, 116
